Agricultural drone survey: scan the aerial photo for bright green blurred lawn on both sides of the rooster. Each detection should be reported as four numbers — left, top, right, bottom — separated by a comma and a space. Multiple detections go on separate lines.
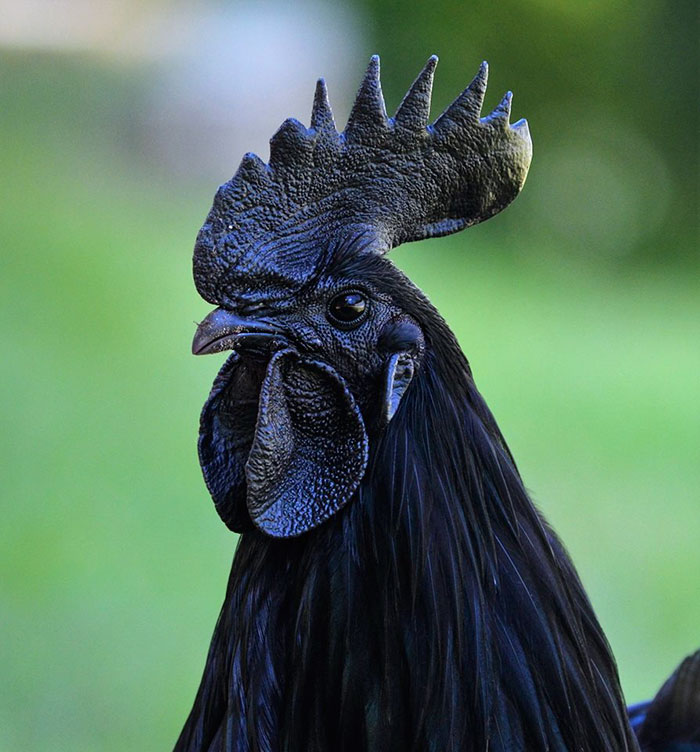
0, 8, 700, 752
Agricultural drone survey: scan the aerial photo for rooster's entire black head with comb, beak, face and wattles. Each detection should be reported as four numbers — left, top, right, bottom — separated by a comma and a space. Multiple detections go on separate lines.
193, 57, 531, 538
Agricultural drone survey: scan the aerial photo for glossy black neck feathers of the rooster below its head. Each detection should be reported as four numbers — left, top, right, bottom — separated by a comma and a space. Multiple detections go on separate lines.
178, 338, 637, 752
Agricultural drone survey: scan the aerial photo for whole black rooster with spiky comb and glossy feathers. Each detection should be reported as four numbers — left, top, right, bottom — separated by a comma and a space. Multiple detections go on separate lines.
176, 57, 700, 752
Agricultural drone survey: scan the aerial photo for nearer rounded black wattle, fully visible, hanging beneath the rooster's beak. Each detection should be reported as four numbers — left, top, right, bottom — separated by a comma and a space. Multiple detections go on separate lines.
245, 350, 368, 538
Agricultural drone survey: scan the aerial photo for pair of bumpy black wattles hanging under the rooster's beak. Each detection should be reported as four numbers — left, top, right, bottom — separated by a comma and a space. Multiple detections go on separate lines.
199, 349, 368, 538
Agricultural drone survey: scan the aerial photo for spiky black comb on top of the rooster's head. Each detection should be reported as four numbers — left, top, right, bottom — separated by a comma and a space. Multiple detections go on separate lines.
194, 55, 532, 304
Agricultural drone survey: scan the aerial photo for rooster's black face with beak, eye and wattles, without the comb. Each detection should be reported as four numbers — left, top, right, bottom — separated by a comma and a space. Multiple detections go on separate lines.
193, 254, 424, 537
